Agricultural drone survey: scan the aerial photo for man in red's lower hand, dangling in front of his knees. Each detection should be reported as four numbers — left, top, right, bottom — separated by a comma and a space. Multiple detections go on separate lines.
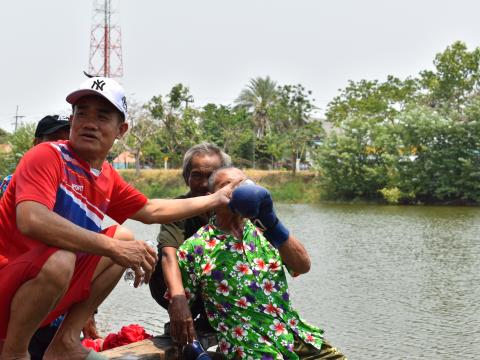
111, 239, 157, 287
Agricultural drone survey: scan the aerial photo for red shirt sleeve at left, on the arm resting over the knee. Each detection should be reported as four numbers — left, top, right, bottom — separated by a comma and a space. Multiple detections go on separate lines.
14, 143, 63, 210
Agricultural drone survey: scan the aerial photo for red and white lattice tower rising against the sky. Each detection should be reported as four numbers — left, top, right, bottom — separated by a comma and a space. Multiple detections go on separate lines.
88, 0, 123, 77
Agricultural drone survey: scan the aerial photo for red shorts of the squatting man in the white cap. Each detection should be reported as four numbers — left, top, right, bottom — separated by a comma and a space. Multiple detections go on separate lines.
0, 225, 117, 340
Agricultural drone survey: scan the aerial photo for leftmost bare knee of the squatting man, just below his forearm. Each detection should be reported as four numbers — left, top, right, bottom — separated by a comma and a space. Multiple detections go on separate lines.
36, 250, 76, 291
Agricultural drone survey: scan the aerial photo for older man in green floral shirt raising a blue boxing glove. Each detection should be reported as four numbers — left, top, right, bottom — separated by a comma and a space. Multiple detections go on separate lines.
178, 167, 344, 359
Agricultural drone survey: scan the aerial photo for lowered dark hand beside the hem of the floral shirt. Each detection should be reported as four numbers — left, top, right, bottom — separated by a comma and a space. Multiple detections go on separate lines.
168, 295, 197, 345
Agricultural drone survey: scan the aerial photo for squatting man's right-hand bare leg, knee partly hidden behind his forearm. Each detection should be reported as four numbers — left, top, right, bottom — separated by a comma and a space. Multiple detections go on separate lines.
44, 227, 134, 360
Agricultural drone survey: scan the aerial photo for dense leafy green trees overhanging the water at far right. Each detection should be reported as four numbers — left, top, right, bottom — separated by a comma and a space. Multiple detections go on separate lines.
315, 42, 480, 204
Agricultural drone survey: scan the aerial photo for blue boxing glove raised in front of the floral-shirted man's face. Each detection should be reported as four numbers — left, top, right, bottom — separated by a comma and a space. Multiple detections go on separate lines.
229, 184, 289, 249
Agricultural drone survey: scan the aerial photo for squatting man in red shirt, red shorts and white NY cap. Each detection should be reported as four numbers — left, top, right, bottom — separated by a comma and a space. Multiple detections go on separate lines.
0, 77, 236, 360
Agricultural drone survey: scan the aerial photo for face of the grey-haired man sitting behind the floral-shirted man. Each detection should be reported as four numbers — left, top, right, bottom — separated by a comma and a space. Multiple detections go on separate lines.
188, 154, 221, 196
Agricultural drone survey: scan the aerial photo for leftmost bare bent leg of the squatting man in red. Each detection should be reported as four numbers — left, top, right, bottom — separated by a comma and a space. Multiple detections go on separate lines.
1, 250, 76, 360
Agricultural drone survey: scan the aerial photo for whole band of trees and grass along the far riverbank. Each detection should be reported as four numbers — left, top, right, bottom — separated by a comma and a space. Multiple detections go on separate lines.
0, 42, 480, 204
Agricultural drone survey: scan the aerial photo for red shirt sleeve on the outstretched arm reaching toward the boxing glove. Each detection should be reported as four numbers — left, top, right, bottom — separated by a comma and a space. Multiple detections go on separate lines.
107, 168, 148, 224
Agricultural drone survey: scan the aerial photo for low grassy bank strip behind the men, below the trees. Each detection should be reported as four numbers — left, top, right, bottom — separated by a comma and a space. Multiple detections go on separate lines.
119, 169, 321, 203
